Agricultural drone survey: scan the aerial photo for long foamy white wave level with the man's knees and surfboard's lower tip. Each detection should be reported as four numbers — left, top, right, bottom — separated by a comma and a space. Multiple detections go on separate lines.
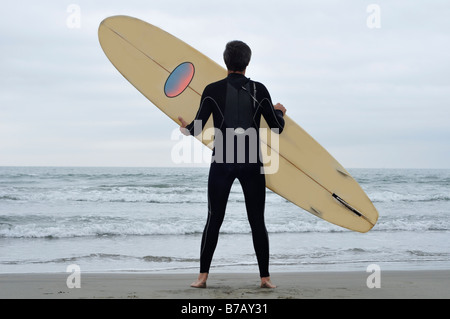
0, 216, 450, 239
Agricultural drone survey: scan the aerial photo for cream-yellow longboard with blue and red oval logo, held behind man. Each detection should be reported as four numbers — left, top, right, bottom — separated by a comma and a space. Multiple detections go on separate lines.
98, 16, 378, 233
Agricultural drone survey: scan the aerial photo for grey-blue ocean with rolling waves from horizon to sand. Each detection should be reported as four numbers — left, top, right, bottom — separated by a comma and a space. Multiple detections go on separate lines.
0, 167, 450, 274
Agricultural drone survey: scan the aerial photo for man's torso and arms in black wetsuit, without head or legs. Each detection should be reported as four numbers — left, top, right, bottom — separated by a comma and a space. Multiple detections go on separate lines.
186, 73, 284, 163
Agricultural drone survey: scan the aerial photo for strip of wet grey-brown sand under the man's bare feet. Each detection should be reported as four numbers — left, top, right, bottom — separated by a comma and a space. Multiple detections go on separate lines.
0, 270, 450, 299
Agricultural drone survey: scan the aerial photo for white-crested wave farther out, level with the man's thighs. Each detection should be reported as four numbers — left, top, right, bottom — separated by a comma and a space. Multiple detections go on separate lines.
0, 183, 450, 203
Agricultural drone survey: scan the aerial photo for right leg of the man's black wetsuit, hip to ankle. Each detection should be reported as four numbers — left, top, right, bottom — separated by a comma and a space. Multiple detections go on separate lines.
238, 165, 270, 277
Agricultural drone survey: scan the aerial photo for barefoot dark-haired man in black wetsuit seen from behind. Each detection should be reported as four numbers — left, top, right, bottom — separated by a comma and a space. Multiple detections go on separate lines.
178, 41, 286, 288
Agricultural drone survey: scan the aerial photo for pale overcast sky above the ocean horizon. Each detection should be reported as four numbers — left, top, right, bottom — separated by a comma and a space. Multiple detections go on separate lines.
0, 0, 450, 168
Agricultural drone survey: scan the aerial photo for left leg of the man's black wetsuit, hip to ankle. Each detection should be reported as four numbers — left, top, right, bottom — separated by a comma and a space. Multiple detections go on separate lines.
200, 163, 236, 273
